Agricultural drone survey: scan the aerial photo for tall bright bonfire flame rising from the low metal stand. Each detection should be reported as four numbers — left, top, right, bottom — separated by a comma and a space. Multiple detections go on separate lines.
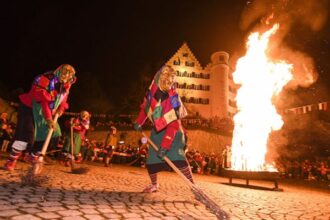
232, 24, 292, 171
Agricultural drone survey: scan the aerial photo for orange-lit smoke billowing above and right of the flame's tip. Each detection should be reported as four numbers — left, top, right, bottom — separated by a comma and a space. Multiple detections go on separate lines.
240, 0, 329, 89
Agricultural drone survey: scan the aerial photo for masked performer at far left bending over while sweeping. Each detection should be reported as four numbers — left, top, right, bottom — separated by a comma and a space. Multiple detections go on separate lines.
4, 64, 76, 170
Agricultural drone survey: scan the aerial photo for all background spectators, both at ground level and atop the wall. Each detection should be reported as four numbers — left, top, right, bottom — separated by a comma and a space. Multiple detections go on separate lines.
0, 112, 330, 184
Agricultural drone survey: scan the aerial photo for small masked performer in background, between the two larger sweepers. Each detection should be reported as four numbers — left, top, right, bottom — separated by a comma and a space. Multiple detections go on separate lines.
63, 111, 91, 162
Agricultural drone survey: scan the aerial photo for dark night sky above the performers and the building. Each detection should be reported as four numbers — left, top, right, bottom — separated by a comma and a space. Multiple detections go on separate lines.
0, 0, 330, 112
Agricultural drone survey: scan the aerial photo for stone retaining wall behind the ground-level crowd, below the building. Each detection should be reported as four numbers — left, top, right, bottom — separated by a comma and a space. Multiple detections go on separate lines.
88, 130, 231, 154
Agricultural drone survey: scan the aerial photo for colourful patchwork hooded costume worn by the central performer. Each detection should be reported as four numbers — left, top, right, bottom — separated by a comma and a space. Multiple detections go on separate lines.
136, 68, 187, 169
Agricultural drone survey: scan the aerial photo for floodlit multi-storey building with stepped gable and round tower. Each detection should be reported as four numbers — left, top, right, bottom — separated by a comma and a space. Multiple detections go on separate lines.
166, 43, 237, 119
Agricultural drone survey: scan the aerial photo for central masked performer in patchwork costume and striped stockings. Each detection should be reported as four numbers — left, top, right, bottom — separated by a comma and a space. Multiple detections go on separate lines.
134, 66, 193, 192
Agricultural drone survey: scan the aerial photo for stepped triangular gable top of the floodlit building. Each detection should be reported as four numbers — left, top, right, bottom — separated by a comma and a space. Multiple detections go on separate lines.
166, 42, 203, 70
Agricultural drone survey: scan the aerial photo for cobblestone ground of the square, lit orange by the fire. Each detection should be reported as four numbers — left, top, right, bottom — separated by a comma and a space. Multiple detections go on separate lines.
0, 160, 330, 220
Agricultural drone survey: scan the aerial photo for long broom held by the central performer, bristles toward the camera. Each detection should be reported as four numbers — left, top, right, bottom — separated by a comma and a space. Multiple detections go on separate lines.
142, 132, 229, 220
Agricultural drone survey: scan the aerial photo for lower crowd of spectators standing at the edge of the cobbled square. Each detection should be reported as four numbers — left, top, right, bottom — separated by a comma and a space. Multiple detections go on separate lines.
58, 140, 330, 181
